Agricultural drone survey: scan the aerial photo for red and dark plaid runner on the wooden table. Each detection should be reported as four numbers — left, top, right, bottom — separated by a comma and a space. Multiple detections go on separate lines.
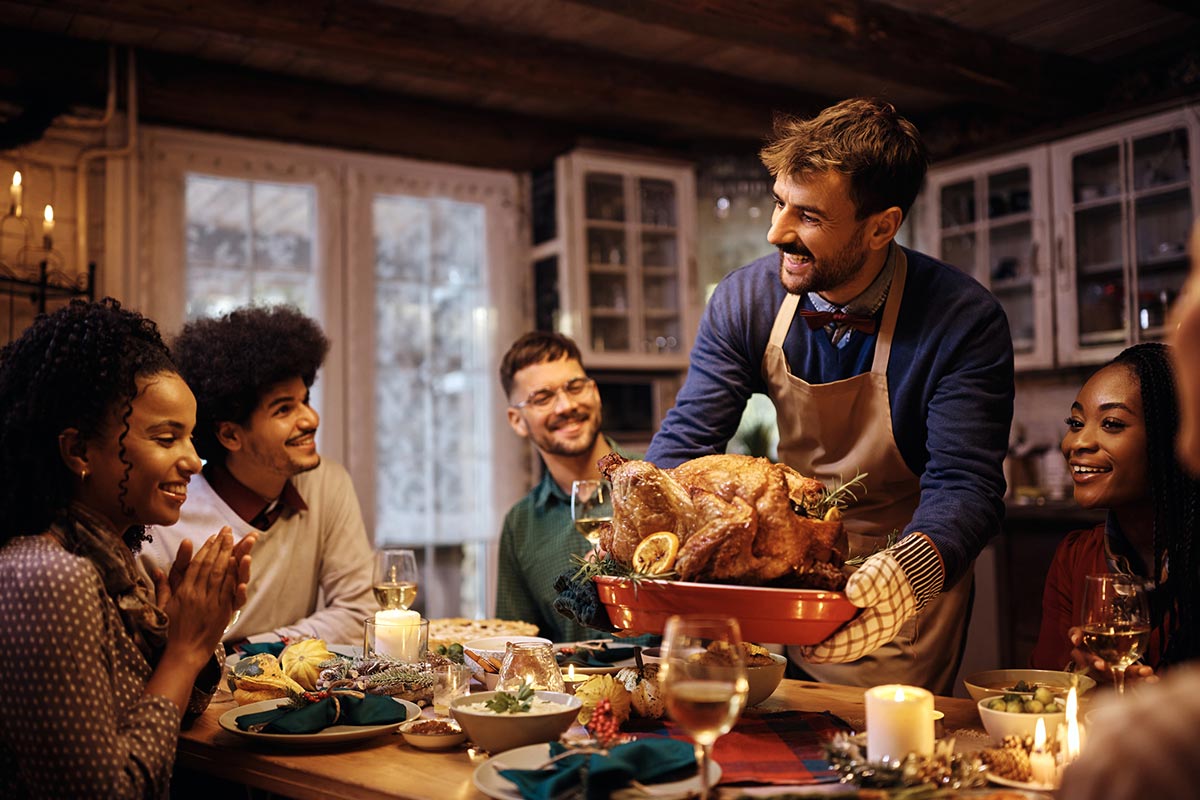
630, 711, 852, 784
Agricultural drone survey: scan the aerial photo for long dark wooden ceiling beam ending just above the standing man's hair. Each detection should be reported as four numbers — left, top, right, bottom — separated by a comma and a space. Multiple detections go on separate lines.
21, 0, 833, 139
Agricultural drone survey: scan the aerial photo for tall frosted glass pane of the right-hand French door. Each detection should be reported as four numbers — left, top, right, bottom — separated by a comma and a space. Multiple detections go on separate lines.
372, 190, 494, 545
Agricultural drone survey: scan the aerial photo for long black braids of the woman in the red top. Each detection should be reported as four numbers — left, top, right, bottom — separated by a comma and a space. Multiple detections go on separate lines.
1112, 343, 1200, 664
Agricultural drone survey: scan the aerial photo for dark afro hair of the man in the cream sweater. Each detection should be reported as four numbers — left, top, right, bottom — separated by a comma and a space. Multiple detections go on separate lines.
173, 306, 329, 463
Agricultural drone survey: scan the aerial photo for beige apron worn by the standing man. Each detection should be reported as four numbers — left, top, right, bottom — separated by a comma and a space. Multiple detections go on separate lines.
763, 245, 973, 694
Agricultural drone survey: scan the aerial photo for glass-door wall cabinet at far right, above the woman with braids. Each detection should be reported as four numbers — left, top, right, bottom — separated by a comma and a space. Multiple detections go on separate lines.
1051, 108, 1200, 365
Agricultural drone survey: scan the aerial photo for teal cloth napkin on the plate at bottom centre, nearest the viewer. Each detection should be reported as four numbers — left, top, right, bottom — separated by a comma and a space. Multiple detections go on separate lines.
499, 739, 696, 800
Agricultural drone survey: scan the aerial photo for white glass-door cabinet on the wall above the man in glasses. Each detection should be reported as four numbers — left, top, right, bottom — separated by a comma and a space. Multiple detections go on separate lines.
533, 150, 698, 369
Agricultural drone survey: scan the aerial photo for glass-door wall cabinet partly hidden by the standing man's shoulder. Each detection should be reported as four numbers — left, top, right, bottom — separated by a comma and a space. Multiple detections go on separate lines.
917, 146, 1054, 369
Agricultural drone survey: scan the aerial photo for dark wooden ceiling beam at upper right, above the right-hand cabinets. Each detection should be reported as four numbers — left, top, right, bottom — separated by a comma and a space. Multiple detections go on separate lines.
570, 0, 1099, 116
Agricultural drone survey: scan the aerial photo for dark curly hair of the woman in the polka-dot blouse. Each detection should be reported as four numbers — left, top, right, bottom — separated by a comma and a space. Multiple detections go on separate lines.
0, 297, 175, 546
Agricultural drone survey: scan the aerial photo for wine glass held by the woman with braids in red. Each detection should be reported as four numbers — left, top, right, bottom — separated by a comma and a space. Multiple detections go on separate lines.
1080, 573, 1150, 694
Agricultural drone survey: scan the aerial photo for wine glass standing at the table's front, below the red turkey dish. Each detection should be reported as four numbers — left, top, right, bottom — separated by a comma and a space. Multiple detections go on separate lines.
659, 615, 749, 800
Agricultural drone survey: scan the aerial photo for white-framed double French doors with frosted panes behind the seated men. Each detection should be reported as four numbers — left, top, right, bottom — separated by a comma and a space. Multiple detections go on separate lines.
136, 128, 528, 616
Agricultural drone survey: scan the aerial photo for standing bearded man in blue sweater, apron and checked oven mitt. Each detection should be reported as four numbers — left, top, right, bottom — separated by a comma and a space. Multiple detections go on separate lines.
647, 98, 1013, 693
